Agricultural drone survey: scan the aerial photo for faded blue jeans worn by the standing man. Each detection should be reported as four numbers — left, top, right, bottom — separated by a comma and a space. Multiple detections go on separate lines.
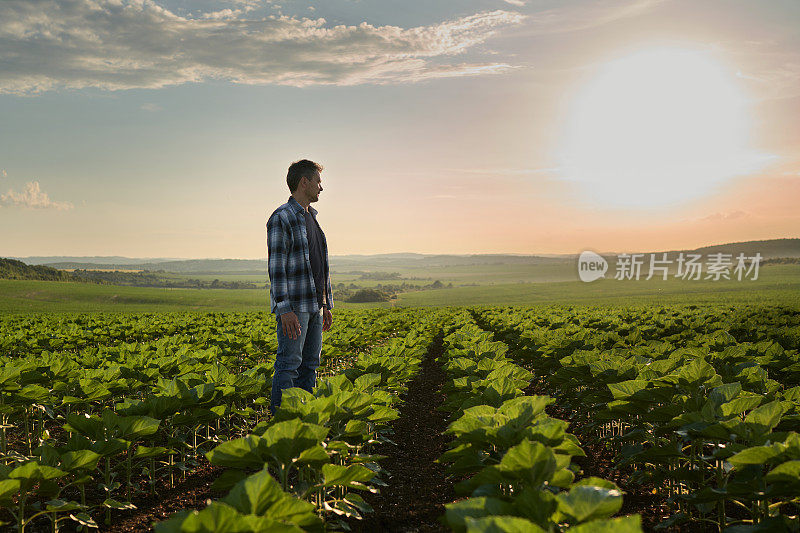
270, 309, 322, 413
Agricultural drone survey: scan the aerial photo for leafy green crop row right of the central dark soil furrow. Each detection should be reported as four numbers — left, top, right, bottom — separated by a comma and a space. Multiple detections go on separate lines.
432, 311, 641, 533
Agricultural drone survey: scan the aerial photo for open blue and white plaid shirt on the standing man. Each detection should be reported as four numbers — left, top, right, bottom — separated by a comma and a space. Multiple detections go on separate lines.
267, 197, 333, 316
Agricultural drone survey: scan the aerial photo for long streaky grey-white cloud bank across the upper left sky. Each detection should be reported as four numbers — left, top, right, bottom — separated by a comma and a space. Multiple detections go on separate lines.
0, 0, 525, 94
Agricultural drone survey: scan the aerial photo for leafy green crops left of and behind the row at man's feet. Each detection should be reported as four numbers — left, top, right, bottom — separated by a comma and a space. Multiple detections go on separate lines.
0, 312, 424, 530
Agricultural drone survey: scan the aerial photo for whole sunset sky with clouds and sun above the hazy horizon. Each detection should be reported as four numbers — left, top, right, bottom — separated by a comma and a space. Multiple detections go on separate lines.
0, 0, 800, 259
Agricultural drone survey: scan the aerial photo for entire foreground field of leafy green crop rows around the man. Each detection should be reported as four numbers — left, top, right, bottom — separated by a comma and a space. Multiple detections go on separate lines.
0, 302, 800, 533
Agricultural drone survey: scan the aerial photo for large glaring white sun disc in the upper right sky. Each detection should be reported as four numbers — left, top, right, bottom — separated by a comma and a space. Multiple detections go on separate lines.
558, 48, 765, 208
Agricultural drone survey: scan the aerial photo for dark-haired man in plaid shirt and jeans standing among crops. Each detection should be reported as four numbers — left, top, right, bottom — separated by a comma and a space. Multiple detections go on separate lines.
267, 159, 333, 414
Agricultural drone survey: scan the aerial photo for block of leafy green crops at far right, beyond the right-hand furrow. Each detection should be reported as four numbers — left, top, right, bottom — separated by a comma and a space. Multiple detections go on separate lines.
474, 308, 800, 532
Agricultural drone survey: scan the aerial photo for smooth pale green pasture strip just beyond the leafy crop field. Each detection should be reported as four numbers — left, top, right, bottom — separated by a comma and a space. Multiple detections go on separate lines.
0, 265, 800, 313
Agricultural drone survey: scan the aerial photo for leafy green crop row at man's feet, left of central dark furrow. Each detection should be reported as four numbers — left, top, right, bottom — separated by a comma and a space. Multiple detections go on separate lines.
156, 310, 438, 533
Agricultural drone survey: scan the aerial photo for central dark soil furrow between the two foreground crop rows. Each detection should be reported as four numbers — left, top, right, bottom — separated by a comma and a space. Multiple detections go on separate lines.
349, 335, 456, 533
